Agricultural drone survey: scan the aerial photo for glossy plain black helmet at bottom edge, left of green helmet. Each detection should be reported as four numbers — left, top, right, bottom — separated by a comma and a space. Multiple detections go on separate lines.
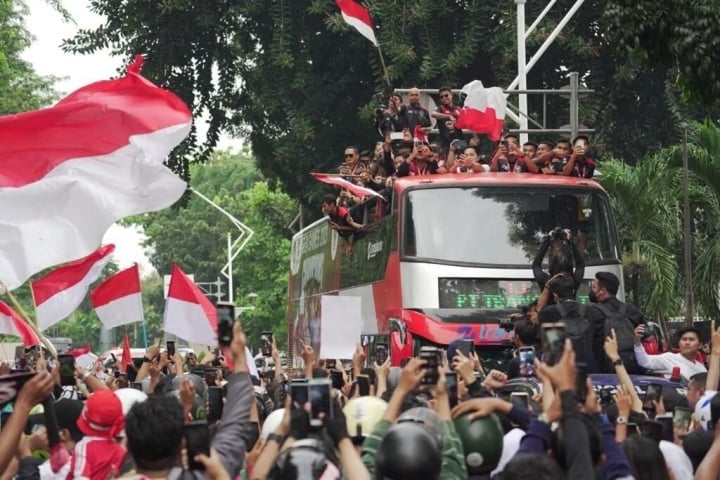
375, 422, 442, 480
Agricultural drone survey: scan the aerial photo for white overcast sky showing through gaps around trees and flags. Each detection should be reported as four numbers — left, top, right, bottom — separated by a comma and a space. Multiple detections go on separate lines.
23, 0, 240, 275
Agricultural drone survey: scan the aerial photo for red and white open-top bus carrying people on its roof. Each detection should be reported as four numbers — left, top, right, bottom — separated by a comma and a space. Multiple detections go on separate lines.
288, 173, 624, 372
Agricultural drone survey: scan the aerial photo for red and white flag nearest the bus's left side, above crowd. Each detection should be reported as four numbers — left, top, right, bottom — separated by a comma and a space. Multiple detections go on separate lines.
163, 264, 217, 345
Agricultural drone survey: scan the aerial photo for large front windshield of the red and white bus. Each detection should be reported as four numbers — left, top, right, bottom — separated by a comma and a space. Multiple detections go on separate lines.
402, 185, 619, 267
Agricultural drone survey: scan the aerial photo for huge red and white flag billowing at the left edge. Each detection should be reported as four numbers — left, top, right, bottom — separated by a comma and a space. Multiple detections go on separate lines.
0, 54, 192, 290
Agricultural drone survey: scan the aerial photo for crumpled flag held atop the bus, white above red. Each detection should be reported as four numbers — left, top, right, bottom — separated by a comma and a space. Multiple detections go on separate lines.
455, 80, 506, 142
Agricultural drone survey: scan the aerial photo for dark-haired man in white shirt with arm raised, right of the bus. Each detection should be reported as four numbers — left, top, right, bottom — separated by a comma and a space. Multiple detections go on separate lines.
635, 325, 707, 379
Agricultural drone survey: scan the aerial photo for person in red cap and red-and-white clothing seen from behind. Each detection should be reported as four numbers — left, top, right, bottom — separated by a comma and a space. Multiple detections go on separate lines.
67, 390, 125, 480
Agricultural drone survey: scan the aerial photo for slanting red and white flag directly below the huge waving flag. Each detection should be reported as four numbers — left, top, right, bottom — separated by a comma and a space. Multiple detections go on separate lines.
30, 244, 115, 331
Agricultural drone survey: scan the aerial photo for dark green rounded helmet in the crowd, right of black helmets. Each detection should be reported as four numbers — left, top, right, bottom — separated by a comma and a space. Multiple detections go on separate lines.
453, 413, 503, 475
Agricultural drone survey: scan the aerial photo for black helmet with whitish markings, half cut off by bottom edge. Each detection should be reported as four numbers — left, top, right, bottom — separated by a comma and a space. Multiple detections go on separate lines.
267, 438, 341, 480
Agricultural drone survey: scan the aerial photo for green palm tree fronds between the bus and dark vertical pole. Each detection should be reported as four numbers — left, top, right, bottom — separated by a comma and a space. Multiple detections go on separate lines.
601, 155, 682, 320
